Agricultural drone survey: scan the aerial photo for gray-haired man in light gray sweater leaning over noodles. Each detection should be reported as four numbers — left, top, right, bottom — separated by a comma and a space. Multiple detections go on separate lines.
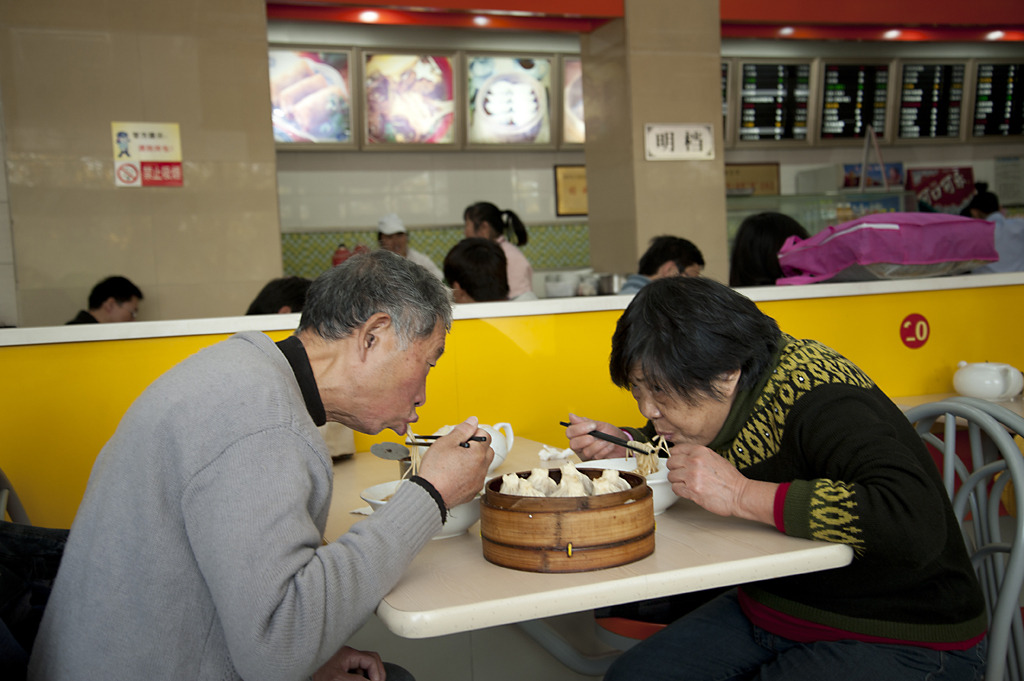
30, 251, 494, 681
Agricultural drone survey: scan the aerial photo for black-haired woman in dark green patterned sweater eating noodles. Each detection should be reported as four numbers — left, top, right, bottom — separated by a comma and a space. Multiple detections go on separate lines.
565, 276, 987, 681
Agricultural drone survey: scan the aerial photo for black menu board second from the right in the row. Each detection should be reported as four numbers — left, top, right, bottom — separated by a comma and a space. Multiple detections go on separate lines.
898, 63, 966, 139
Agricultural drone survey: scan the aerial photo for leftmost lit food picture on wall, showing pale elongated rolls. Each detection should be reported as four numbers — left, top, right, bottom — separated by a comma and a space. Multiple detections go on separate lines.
269, 49, 352, 143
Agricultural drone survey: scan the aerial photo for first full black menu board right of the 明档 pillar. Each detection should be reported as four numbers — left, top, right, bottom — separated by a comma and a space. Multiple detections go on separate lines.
739, 63, 811, 141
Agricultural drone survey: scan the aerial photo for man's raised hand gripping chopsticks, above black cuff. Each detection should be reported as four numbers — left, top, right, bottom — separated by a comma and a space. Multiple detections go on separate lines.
420, 416, 495, 508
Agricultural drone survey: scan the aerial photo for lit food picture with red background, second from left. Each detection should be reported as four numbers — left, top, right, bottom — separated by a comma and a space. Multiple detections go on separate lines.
362, 54, 456, 146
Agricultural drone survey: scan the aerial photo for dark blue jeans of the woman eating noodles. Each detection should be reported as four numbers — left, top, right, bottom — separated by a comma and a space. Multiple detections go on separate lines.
604, 590, 986, 681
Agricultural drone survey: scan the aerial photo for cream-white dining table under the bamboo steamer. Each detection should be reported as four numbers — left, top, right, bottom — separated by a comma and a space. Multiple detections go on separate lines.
325, 437, 853, 638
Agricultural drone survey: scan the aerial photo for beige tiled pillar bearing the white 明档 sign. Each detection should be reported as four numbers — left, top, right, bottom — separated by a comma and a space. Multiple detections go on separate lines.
581, 0, 728, 282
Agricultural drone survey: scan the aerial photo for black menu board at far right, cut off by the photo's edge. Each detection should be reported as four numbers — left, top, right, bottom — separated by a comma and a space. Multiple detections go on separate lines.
973, 63, 1024, 137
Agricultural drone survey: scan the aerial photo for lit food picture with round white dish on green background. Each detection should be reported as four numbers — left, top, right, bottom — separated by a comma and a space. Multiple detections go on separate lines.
466, 55, 553, 144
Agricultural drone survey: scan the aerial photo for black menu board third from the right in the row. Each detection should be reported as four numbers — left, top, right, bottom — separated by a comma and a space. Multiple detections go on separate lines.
821, 63, 889, 139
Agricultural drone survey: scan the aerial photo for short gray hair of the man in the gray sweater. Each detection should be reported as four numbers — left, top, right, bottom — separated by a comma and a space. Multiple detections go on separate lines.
298, 250, 452, 348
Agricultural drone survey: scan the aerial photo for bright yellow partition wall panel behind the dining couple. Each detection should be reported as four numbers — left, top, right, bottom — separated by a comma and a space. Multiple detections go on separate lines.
0, 286, 1024, 526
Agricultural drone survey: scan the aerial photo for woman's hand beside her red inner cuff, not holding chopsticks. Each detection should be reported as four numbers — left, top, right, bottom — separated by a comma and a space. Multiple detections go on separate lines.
667, 444, 778, 525
